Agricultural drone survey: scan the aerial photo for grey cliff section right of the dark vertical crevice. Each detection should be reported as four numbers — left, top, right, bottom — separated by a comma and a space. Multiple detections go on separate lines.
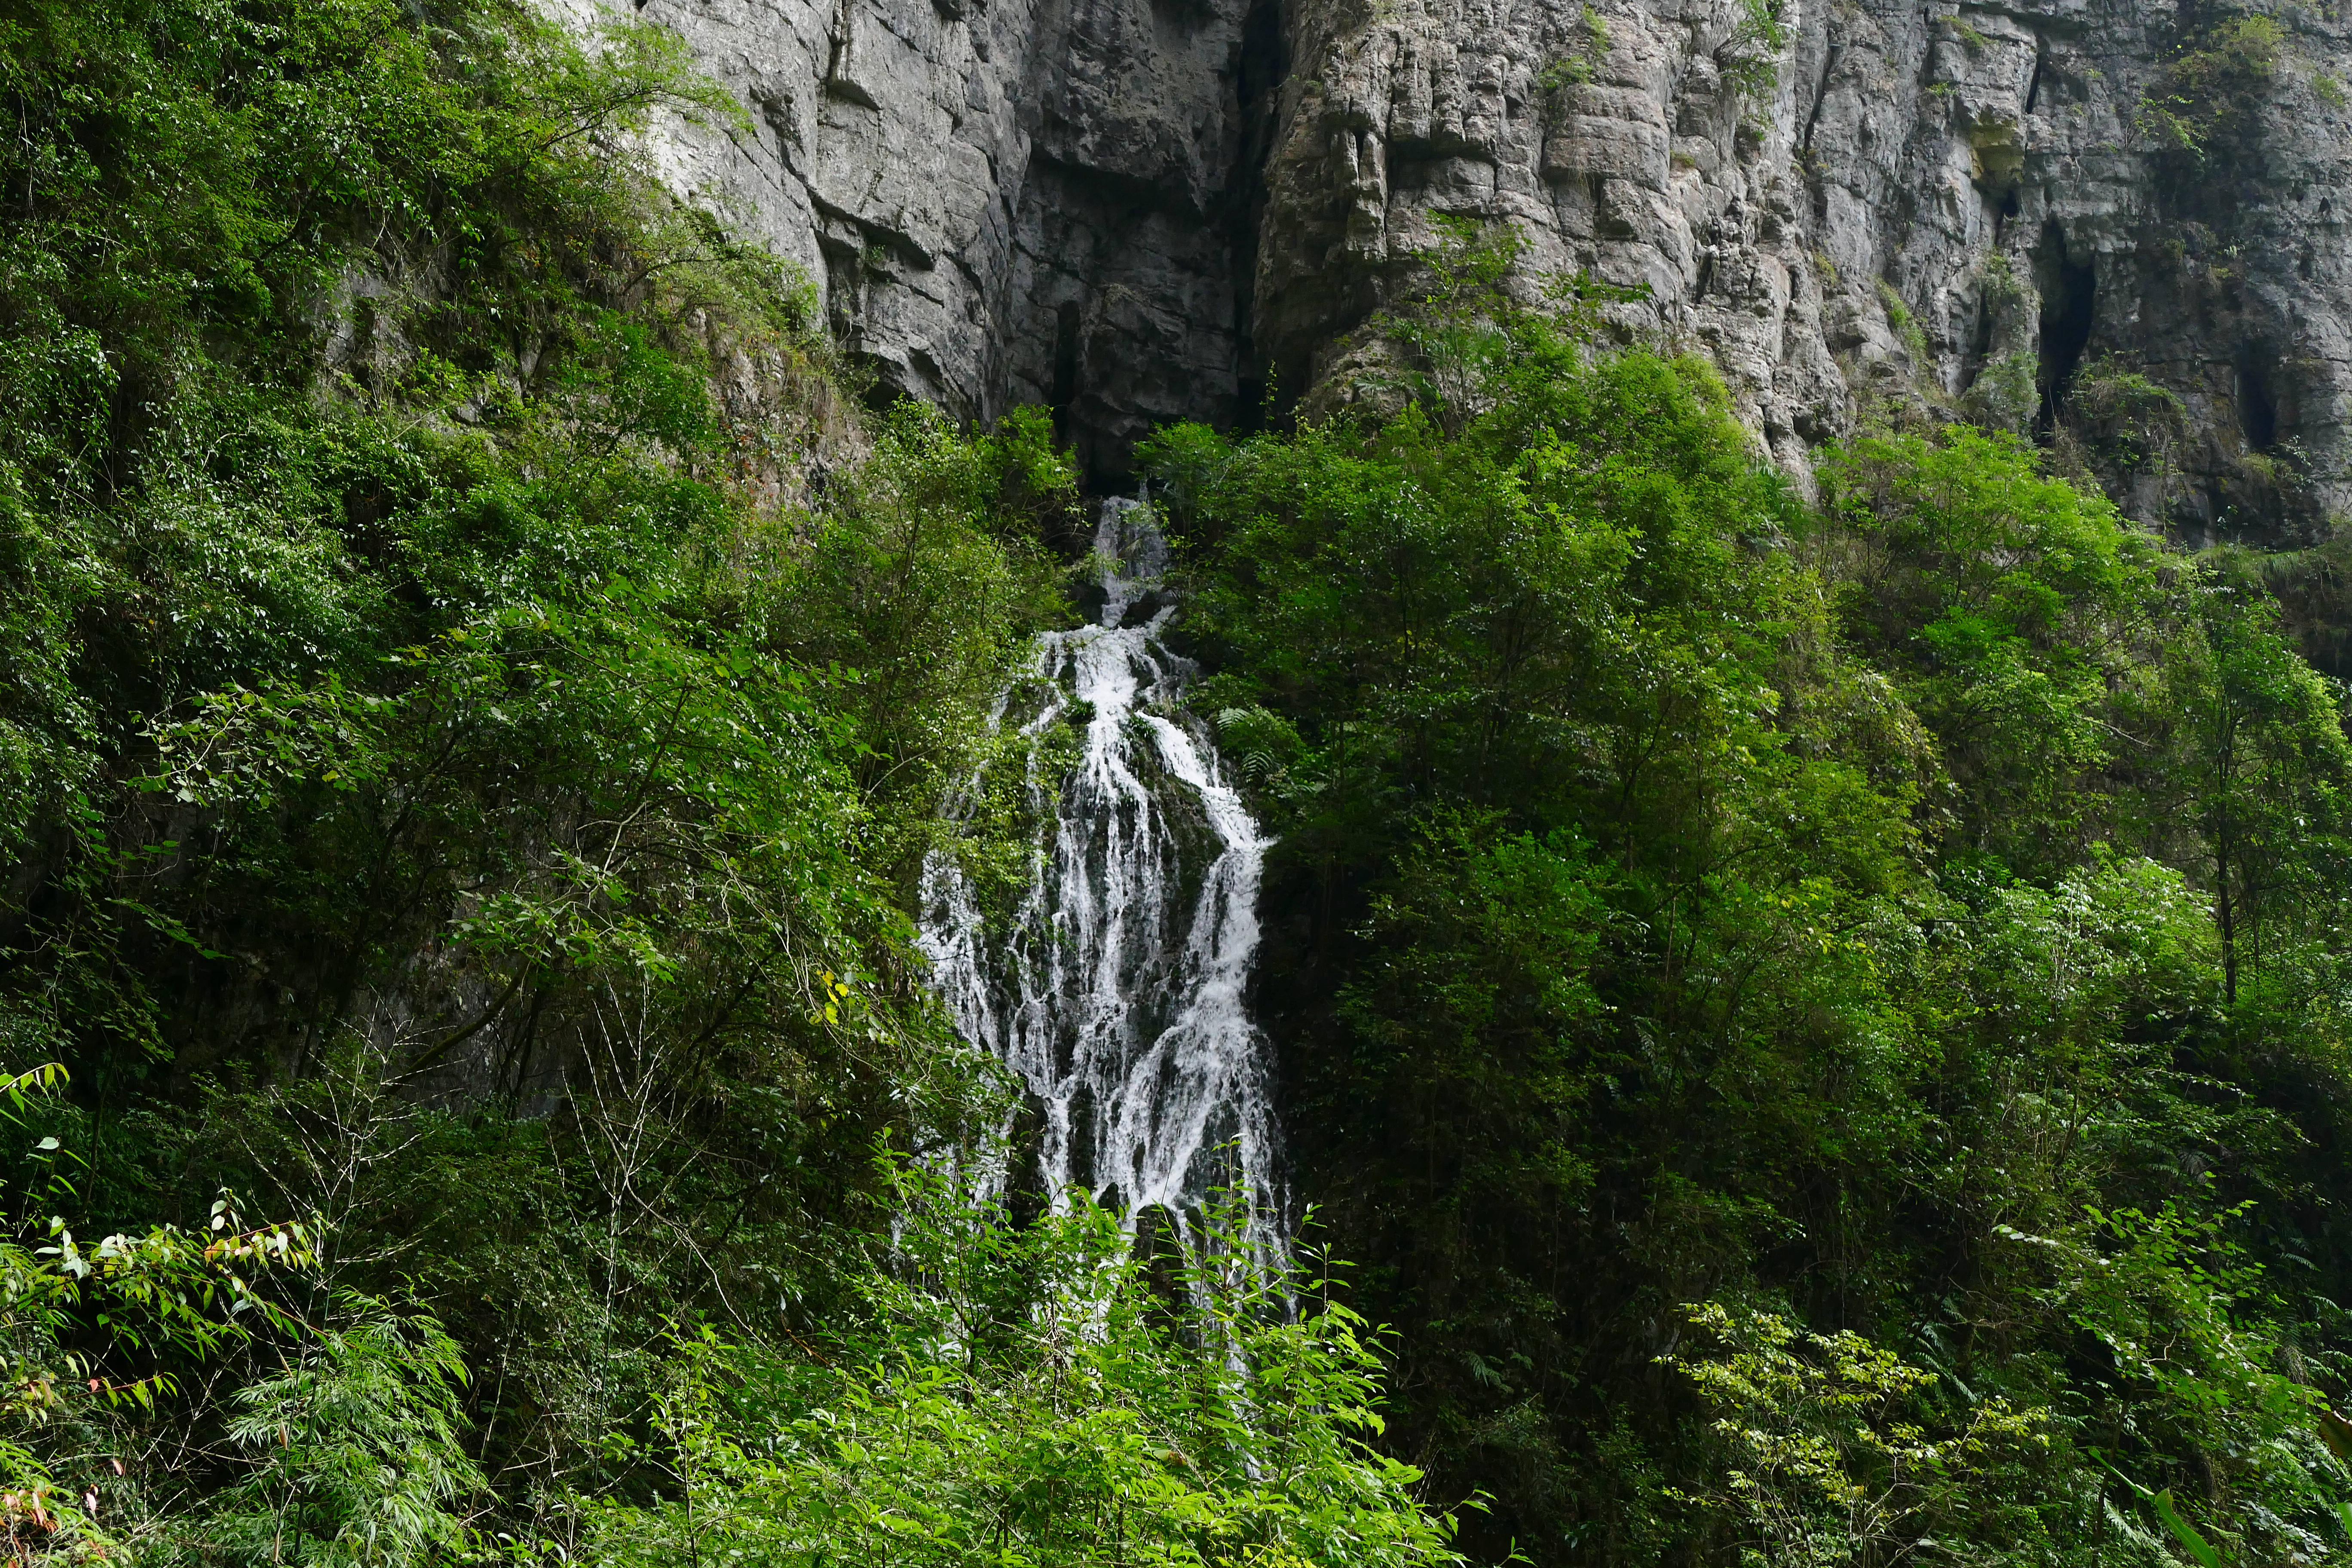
1256, 0, 2352, 543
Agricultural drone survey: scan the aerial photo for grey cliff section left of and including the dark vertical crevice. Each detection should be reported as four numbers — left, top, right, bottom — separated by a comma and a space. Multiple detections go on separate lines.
607, 0, 1282, 475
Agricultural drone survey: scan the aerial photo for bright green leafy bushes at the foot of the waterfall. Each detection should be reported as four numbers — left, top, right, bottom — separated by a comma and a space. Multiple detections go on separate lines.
586, 1176, 1461, 1566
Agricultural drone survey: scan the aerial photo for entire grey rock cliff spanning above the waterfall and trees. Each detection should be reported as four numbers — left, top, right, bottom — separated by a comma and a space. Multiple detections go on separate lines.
621, 0, 2352, 543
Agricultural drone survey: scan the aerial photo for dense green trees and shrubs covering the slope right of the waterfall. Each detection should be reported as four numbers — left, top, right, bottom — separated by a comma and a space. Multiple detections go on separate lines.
1152, 240, 2352, 1563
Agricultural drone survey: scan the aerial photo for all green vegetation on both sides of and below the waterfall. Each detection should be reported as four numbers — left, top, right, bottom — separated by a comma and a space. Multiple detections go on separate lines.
0, 0, 2352, 1568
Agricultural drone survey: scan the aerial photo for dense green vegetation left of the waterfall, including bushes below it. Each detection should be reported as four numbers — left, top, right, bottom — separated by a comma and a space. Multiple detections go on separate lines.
0, 0, 1446, 1563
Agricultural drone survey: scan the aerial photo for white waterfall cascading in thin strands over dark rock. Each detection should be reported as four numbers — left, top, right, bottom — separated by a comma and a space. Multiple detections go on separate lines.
922, 501, 1284, 1260
